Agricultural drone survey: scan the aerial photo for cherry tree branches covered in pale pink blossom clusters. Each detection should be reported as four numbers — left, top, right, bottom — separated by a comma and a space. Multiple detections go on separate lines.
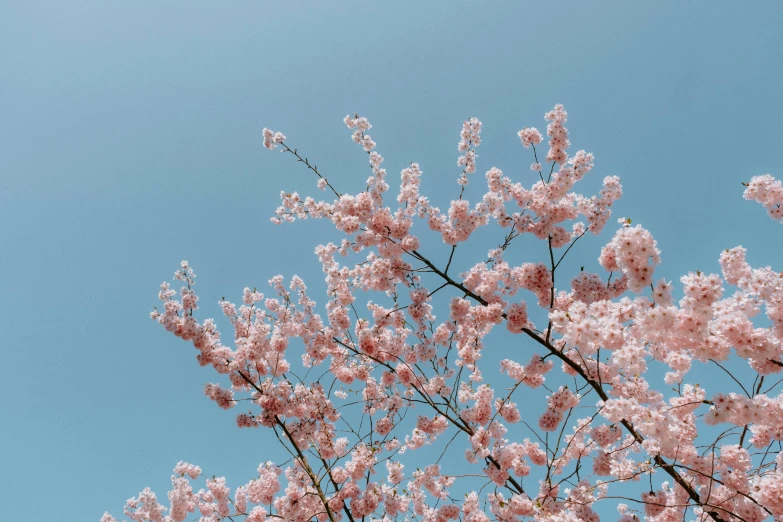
101, 105, 783, 522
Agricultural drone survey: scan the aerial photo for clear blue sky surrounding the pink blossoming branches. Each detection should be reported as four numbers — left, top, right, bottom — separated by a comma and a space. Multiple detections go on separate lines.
0, 0, 783, 522
